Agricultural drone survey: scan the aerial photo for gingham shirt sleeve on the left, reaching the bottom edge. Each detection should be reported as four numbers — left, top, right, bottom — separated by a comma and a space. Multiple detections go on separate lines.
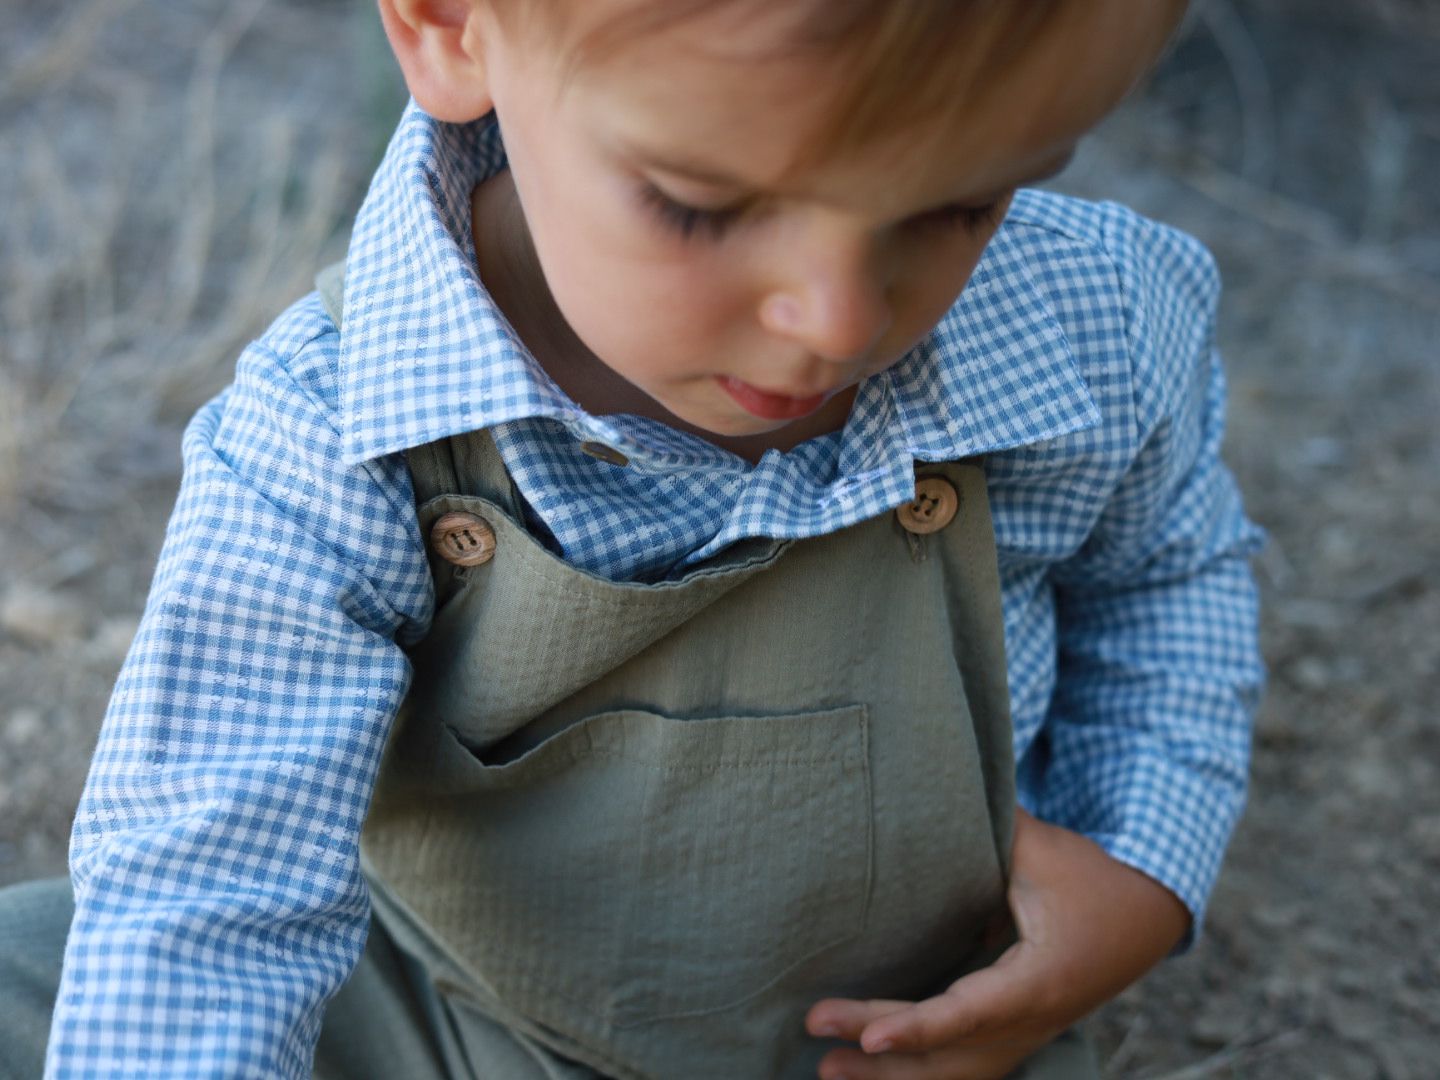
46, 311, 432, 1080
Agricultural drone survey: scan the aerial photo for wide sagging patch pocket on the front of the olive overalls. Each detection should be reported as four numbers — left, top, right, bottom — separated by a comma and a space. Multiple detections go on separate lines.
425, 706, 874, 1027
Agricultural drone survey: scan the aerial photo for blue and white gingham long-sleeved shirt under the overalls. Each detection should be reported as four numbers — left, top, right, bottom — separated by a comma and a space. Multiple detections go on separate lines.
48, 107, 1261, 1079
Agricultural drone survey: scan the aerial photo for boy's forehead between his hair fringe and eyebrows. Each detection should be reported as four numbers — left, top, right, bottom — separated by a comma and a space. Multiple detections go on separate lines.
552, 0, 1182, 203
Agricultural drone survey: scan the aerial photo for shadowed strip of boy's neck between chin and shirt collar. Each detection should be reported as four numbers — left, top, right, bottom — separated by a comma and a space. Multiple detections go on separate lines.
471, 168, 855, 462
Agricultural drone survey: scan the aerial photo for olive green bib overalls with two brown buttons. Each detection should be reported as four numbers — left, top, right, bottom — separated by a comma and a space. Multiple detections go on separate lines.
312, 257, 1093, 1080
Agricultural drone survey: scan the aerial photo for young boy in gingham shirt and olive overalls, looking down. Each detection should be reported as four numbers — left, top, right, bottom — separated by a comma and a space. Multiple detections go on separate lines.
0, 0, 1260, 1080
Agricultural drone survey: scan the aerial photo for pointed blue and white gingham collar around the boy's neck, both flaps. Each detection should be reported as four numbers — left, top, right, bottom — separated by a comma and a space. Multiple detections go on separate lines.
340, 102, 1100, 483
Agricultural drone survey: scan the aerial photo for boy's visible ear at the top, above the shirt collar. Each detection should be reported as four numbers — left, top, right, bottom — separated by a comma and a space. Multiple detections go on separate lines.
380, 0, 492, 124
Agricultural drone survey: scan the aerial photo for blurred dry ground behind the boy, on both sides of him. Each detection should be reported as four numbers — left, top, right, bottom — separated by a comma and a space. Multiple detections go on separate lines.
0, 0, 1440, 1080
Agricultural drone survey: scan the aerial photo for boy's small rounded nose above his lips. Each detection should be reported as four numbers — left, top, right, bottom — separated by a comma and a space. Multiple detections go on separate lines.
760, 244, 891, 363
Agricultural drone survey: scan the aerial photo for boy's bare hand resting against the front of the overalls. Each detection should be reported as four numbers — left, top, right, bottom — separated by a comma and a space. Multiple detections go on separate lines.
805, 811, 1189, 1080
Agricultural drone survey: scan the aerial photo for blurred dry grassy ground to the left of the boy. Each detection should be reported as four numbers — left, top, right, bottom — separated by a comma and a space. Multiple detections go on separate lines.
0, 0, 397, 880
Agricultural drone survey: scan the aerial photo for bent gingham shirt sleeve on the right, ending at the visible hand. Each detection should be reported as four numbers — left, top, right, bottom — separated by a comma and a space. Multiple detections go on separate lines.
1034, 216, 1263, 945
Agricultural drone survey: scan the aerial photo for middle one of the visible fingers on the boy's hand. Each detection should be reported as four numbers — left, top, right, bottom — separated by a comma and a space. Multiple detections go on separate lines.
860, 943, 1048, 1054
